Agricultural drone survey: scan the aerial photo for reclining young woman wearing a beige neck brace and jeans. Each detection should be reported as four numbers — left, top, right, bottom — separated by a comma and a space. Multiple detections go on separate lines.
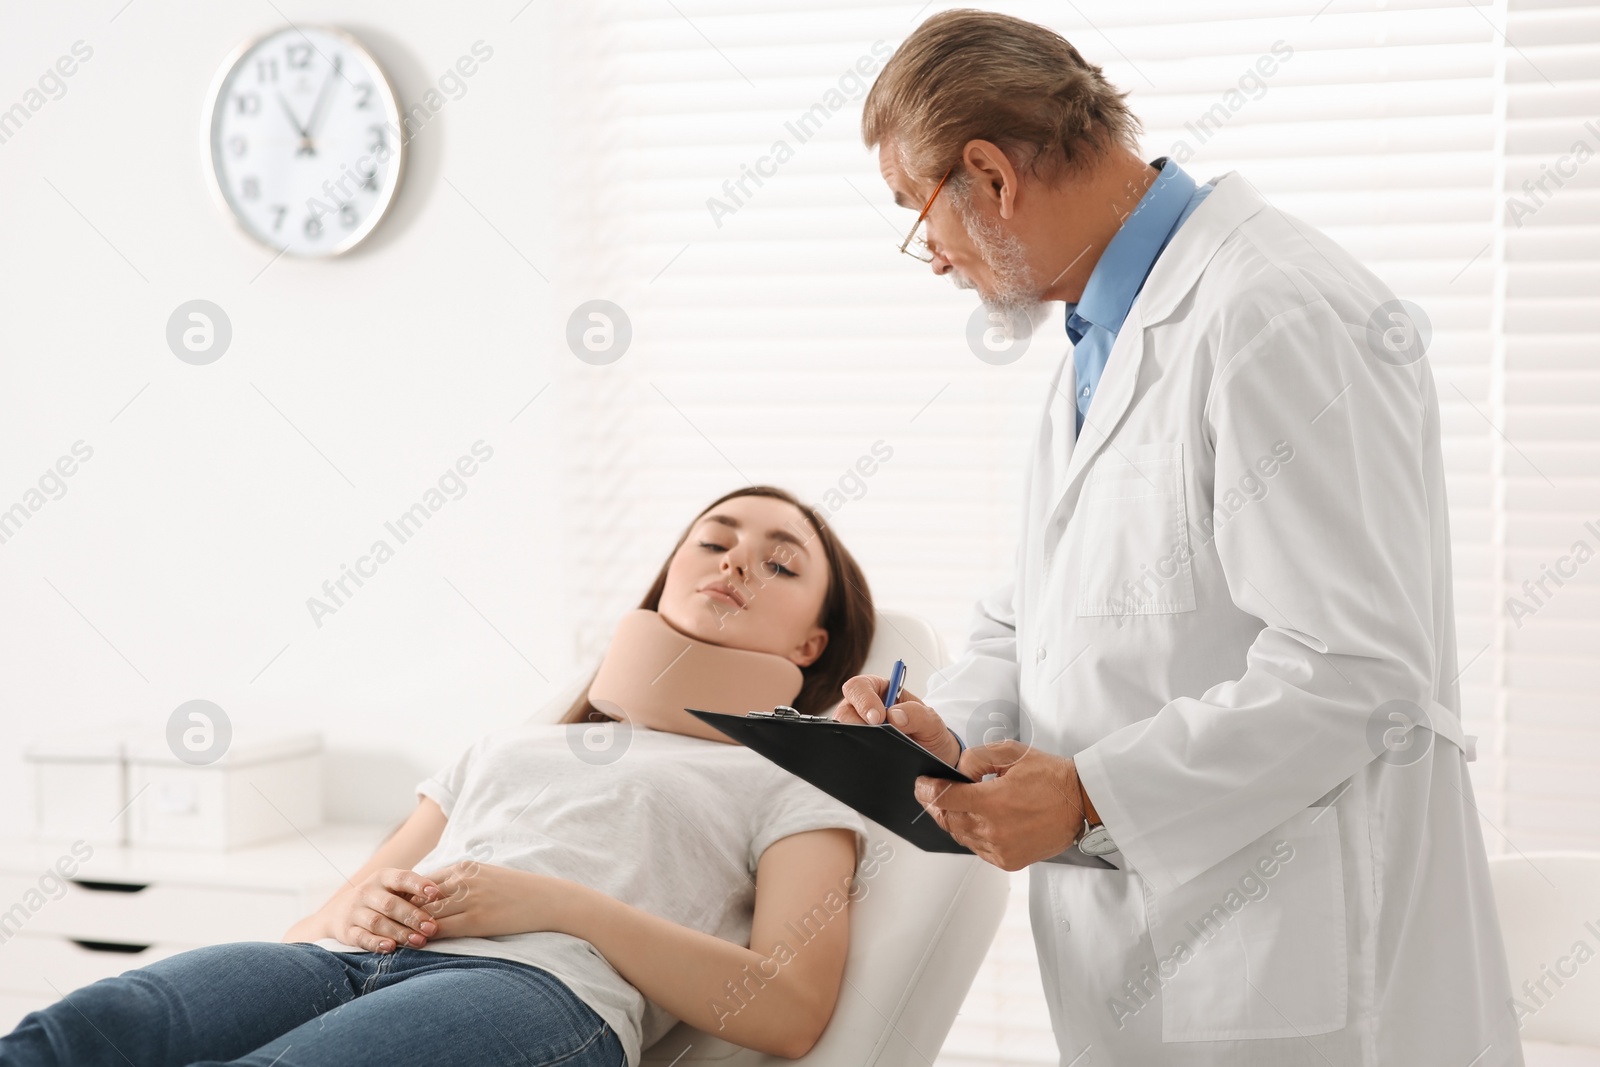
0, 486, 874, 1067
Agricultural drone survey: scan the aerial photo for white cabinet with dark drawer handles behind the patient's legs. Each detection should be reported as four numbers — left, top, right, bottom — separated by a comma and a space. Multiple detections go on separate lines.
0, 824, 392, 1033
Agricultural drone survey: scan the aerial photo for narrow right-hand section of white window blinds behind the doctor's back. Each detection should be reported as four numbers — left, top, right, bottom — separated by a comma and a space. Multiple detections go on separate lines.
1483, 0, 1600, 851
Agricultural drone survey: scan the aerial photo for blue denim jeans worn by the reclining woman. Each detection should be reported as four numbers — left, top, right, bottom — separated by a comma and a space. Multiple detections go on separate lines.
0, 941, 627, 1067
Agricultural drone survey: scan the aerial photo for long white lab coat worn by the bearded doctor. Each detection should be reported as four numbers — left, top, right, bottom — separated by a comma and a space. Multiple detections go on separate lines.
926, 173, 1522, 1067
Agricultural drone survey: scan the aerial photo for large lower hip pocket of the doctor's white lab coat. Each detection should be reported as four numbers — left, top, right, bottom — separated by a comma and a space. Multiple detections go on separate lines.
1144, 806, 1347, 1041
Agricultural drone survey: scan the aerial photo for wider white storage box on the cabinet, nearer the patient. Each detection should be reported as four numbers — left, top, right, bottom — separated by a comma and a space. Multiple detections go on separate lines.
128, 733, 322, 848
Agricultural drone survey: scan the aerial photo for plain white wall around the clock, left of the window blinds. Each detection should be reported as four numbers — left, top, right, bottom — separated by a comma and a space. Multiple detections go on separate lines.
0, 0, 574, 833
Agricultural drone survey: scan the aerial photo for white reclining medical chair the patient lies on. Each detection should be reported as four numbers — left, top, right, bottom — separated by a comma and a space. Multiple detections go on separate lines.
643, 611, 1011, 1067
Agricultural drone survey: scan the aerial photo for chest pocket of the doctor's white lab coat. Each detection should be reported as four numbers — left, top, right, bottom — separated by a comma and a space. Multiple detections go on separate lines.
1077, 442, 1195, 616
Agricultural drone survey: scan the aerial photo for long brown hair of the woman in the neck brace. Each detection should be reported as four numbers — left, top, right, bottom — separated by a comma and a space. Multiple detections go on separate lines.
557, 485, 877, 723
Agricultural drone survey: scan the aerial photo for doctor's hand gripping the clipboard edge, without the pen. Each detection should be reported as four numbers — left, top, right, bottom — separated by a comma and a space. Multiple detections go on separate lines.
917, 741, 1083, 870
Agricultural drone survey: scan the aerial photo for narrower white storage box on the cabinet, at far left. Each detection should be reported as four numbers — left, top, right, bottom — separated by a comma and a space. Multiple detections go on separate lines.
22, 728, 128, 845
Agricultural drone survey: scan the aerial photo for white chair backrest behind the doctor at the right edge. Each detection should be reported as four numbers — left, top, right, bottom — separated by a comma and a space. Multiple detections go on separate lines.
1490, 853, 1600, 1046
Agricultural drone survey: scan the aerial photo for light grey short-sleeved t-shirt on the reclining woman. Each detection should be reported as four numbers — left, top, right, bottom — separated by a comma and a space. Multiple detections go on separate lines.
317, 723, 867, 1067
